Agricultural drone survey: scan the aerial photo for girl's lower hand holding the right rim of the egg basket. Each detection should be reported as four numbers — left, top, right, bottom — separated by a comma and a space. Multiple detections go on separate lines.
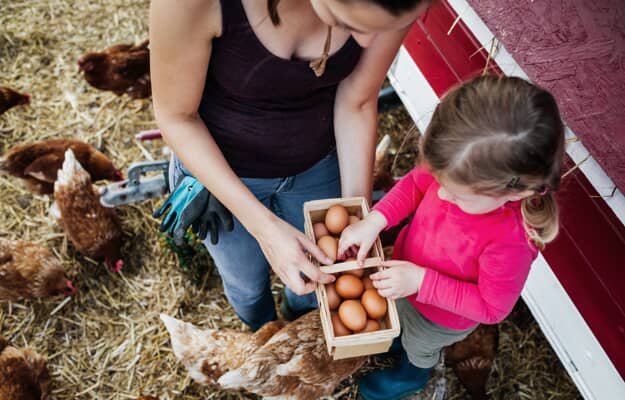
369, 260, 425, 300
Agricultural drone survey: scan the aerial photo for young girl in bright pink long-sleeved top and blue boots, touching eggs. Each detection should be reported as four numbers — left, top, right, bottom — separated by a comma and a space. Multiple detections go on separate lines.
339, 76, 564, 400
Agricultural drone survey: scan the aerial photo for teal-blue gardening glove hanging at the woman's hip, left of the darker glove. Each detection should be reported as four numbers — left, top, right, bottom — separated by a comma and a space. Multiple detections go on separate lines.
152, 176, 208, 239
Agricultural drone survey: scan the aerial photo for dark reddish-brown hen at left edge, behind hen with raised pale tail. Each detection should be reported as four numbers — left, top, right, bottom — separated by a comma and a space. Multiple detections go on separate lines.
0, 139, 124, 194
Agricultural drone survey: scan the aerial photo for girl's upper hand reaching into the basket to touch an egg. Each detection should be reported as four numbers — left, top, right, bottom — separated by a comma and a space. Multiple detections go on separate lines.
337, 210, 388, 266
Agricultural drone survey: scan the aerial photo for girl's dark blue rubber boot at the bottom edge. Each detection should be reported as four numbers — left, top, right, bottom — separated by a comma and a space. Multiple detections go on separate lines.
358, 352, 434, 400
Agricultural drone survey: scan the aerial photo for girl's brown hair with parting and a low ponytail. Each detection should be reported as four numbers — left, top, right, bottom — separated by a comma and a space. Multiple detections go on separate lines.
421, 76, 564, 249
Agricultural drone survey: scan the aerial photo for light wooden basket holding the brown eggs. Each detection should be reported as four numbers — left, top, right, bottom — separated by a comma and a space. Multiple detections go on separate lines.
304, 197, 400, 360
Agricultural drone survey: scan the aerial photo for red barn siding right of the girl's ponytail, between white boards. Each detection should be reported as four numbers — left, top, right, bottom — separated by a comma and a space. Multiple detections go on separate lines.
543, 157, 625, 377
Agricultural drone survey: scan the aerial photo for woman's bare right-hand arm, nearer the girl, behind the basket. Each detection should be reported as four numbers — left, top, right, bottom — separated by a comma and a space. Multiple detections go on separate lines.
334, 29, 408, 203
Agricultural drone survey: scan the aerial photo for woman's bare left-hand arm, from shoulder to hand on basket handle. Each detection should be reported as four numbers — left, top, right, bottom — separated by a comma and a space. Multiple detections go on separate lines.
150, 0, 333, 294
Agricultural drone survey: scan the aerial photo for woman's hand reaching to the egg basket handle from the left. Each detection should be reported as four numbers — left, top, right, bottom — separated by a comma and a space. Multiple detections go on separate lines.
256, 217, 335, 296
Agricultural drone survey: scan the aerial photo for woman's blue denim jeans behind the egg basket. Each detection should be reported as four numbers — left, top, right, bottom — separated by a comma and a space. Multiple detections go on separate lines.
169, 151, 341, 330
